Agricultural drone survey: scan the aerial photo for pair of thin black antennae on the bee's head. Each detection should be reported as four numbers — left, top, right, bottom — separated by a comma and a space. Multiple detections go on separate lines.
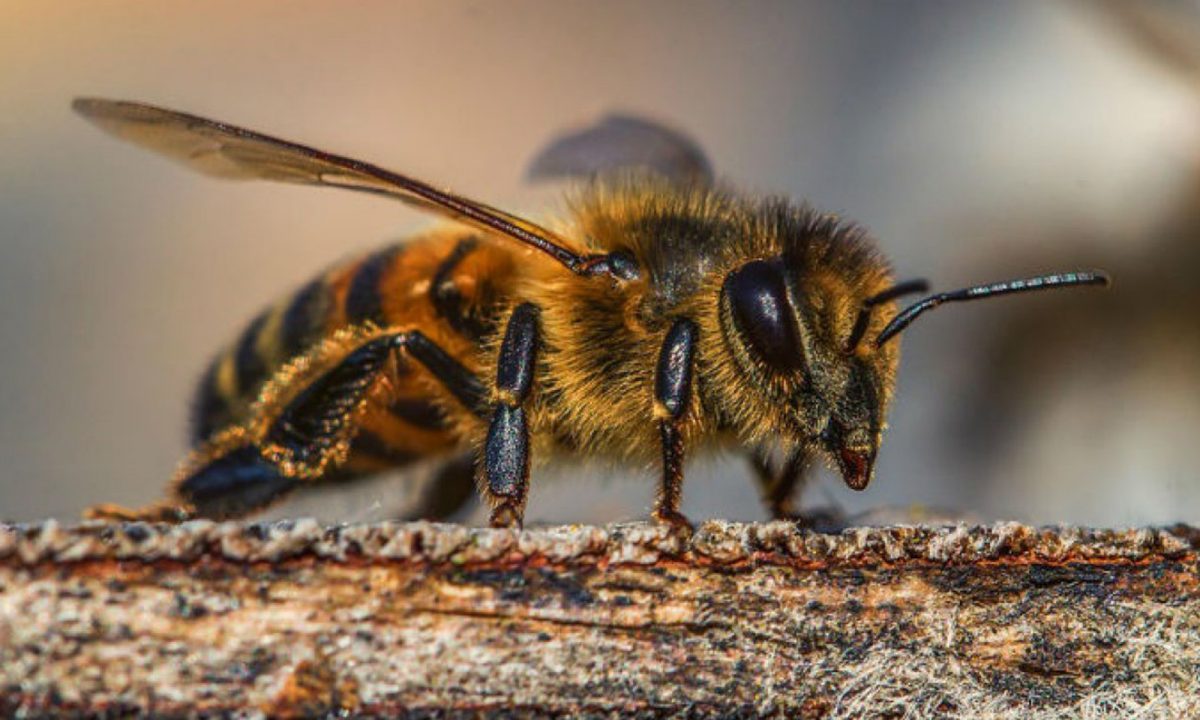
847, 270, 1112, 352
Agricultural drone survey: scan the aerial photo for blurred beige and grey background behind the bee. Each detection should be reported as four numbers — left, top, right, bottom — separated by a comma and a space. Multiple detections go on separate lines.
0, 0, 1200, 526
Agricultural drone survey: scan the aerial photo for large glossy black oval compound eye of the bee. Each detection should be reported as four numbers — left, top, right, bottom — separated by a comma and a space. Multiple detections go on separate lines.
725, 258, 804, 372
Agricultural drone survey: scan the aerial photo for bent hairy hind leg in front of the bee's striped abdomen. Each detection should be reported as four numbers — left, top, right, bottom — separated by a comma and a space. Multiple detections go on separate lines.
85, 330, 484, 521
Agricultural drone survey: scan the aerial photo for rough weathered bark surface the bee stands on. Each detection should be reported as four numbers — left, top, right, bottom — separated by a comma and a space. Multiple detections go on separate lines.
0, 521, 1200, 718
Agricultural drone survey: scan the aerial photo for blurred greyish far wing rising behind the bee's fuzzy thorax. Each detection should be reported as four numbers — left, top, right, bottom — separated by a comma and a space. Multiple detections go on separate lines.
526, 114, 713, 185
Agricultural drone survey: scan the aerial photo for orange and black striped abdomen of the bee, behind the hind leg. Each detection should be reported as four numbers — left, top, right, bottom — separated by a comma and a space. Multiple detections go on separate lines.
192, 230, 512, 470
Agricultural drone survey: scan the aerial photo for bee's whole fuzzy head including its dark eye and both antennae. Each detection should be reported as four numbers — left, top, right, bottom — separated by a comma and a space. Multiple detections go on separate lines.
718, 238, 1109, 490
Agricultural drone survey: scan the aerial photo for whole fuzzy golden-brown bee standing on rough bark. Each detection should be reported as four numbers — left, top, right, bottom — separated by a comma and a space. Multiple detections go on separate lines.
73, 98, 1109, 528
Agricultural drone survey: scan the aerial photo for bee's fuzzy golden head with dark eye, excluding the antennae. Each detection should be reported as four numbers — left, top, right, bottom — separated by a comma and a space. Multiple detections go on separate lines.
721, 254, 899, 490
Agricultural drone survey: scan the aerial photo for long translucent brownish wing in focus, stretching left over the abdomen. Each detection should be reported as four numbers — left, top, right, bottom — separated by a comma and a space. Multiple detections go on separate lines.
72, 97, 589, 272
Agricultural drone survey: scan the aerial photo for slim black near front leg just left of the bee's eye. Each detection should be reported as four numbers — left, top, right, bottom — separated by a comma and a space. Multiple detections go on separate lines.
654, 319, 697, 532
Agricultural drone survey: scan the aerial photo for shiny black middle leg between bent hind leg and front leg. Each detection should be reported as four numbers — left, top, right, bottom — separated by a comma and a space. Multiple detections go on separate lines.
481, 302, 539, 527
